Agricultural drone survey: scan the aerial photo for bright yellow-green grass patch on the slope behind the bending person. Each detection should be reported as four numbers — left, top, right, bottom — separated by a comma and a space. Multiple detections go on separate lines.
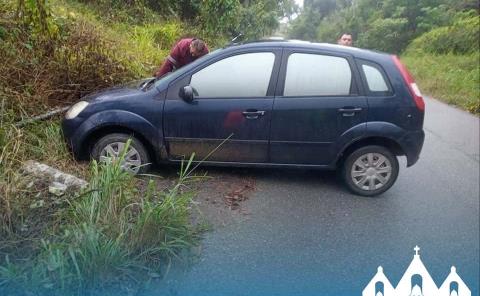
52, 0, 188, 78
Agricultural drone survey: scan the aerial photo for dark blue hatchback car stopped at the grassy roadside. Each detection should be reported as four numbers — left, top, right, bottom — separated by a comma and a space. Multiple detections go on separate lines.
63, 41, 425, 196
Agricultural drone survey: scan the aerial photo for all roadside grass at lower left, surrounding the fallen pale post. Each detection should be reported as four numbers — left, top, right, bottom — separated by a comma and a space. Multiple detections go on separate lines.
0, 114, 203, 296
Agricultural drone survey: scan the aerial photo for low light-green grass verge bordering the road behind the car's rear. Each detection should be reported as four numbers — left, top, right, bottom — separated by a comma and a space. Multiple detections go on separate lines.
402, 52, 480, 115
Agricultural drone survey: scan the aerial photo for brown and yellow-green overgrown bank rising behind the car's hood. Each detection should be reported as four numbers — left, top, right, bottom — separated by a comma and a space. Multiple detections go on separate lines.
0, 0, 188, 120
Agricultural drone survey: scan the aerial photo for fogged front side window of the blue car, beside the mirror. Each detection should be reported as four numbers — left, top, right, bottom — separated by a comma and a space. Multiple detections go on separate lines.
190, 52, 275, 98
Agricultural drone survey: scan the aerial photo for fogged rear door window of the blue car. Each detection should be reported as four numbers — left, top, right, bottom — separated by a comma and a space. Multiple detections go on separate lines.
283, 53, 352, 96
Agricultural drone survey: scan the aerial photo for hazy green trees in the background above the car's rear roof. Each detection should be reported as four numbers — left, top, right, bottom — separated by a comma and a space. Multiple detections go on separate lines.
289, 0, 478, 53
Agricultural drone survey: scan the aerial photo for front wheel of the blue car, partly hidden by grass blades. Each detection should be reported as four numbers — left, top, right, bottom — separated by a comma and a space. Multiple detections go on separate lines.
90, 133, 151, 174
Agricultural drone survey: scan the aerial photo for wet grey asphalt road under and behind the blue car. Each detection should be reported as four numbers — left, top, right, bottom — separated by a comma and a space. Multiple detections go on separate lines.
155, 99, 480, 295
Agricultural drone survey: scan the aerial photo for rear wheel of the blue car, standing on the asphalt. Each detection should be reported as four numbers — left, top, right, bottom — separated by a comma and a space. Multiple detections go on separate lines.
342, 145, 399, 196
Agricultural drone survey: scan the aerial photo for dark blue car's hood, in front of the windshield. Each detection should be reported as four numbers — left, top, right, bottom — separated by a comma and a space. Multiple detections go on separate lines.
82, 78, 153, 103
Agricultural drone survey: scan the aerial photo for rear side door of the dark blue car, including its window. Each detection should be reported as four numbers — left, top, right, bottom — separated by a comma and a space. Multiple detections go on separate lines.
270, 49, 367, 166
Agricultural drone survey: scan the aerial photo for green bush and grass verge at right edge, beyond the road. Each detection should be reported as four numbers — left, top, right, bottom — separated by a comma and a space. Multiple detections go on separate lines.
402, 11, 480, 114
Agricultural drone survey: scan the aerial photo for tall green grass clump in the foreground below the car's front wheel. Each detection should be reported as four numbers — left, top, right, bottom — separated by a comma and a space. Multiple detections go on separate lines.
0, 145, 200, 295
